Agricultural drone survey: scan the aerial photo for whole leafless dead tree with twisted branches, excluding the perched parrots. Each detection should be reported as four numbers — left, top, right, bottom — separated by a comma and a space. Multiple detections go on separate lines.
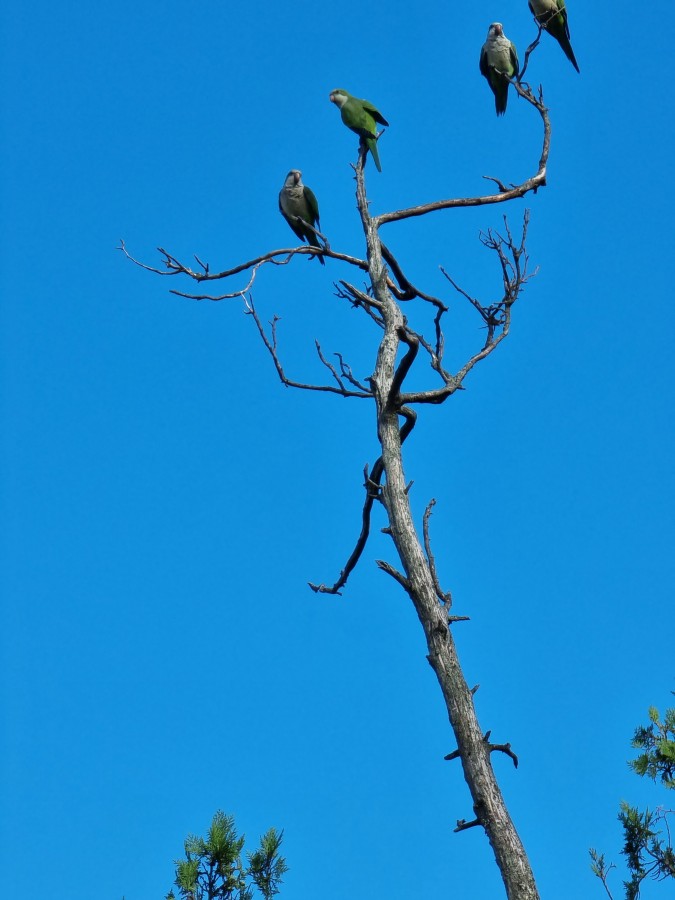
120, 49, 550, 900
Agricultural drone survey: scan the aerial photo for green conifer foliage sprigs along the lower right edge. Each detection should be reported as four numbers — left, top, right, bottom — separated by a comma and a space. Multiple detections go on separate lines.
589, 706, 675, 900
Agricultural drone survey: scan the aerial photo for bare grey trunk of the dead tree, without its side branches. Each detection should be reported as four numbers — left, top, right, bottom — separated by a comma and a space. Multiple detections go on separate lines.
356, 155, 539, 900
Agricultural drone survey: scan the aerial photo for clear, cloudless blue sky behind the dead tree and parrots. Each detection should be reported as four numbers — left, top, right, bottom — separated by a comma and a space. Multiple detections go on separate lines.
0, 0, 675, 900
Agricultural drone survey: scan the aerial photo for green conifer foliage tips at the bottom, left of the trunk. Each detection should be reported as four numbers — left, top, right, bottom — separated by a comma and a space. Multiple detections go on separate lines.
166, 810, 288, 900
